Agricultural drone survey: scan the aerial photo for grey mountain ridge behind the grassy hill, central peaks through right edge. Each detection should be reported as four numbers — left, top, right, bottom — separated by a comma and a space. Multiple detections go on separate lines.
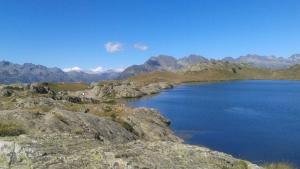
120, 54, 300, 78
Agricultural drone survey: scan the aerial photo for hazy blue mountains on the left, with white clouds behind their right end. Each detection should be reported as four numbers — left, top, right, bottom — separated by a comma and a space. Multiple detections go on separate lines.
0, 61, 118, 84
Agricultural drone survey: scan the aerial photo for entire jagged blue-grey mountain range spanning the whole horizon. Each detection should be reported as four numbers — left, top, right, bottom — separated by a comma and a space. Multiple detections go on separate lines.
0, 54, 300, 84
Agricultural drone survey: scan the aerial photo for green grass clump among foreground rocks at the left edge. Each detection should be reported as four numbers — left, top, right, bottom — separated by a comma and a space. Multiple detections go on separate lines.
0, 122, 25, 137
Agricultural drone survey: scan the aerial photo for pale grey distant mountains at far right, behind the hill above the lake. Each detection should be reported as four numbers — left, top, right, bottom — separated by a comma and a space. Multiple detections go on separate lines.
223, 54, 300, 69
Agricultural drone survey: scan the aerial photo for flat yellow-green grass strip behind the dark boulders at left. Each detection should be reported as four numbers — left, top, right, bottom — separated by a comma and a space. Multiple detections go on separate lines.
48, 83, 89, 91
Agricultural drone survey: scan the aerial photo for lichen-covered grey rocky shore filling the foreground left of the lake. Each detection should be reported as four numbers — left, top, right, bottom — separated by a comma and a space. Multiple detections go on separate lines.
0, 80, 261, 169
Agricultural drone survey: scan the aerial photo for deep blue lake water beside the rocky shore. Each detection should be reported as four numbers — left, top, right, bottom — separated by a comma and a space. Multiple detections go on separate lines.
129, 81, 300, 166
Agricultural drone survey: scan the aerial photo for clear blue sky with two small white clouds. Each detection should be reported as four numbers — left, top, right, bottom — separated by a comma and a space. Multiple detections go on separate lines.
0, 0, 300, 70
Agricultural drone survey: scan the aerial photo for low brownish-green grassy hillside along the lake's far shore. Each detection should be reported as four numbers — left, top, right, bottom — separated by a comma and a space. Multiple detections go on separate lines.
129, 61, 300, 84
